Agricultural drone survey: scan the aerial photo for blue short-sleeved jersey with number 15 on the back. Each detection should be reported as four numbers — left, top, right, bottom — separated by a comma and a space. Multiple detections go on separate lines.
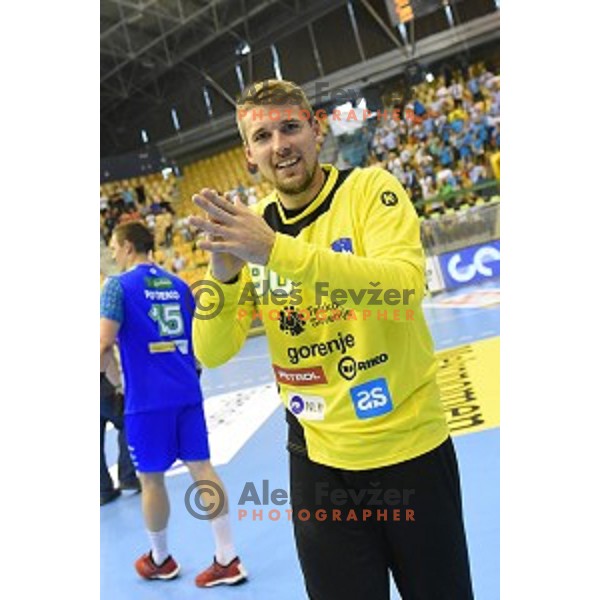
100, 264, 202, 414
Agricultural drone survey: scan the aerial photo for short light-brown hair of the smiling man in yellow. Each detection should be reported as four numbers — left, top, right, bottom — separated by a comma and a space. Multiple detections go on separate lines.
235, 79, 314, 142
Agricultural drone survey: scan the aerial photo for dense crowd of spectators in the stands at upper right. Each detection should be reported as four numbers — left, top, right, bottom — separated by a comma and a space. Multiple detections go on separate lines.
368, 64, 500, 209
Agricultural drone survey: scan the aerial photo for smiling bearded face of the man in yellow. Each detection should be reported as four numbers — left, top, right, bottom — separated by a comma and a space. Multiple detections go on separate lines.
241, 104, 322, 195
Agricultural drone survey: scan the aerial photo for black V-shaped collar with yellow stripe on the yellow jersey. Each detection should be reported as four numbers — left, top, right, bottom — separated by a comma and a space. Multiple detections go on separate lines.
263, 165, 353, 237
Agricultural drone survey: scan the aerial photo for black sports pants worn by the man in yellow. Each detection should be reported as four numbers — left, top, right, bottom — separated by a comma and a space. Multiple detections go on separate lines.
290, 438, 473, 600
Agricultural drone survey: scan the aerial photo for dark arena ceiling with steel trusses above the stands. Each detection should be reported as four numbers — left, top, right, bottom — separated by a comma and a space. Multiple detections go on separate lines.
100, 0, 494, 156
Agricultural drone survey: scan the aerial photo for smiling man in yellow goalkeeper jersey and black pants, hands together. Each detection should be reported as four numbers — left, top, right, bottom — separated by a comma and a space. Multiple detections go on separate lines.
192, 80, 473, 600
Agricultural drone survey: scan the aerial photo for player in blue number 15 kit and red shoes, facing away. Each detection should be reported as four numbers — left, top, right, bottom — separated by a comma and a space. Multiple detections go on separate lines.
100, 221, 247, 587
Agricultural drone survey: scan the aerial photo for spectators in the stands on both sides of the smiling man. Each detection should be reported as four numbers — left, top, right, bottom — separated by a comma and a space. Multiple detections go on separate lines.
100, 58, 500, 272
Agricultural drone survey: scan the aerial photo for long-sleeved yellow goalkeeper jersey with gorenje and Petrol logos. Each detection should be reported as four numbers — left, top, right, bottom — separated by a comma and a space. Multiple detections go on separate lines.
193, 165, 448, 470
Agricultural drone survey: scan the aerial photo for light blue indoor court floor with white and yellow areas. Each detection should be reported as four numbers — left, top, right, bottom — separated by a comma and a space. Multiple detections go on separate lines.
100, 281, 500, 600
